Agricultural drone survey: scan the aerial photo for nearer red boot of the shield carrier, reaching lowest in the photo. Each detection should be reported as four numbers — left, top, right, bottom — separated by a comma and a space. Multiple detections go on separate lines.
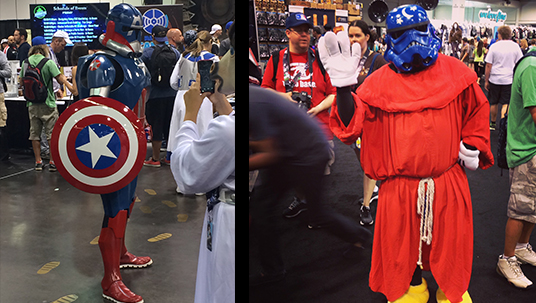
99, 210, 143, 303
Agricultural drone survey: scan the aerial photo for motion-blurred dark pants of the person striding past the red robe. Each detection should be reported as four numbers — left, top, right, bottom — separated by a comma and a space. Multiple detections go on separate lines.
250, 161, 372, 274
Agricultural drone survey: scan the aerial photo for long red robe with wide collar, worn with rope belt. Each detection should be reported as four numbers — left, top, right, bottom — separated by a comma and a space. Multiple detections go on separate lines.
330, 54, 493, 302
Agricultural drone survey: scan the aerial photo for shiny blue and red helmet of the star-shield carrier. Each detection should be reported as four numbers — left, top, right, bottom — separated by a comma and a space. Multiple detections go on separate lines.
100, 3, 143, 53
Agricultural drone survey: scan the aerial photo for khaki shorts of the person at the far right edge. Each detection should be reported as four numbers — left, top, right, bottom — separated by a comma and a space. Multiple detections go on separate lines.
507, 156, 536, 223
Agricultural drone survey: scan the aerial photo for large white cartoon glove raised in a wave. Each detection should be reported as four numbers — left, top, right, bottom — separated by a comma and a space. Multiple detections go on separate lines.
318, 30, 361, 87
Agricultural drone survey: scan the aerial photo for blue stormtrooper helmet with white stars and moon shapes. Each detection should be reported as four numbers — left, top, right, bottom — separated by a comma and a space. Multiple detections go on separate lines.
385, 4, 441, 72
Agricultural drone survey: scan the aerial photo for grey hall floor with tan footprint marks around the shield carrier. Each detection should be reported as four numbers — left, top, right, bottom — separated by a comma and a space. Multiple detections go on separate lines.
0, 147, 206, 303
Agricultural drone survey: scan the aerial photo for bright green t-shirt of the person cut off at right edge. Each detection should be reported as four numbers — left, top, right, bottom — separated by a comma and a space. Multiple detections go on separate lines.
506, 47, 536, 168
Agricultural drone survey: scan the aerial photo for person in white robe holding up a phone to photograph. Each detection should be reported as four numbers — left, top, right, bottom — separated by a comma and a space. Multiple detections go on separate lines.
171, 22, 235, 303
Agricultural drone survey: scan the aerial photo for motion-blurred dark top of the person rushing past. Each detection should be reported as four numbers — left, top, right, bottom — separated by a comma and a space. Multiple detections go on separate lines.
249, 85, 329, 165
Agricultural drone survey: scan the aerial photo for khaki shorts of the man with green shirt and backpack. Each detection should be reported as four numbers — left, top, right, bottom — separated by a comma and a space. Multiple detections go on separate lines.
28, 103, 59, 141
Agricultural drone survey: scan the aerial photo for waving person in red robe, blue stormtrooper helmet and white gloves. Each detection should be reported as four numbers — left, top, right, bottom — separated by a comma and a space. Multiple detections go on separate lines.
319, 5, 493, 303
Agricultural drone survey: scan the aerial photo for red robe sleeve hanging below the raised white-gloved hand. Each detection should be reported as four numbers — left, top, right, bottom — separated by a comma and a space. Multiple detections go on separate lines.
329, 93, 365, 145
